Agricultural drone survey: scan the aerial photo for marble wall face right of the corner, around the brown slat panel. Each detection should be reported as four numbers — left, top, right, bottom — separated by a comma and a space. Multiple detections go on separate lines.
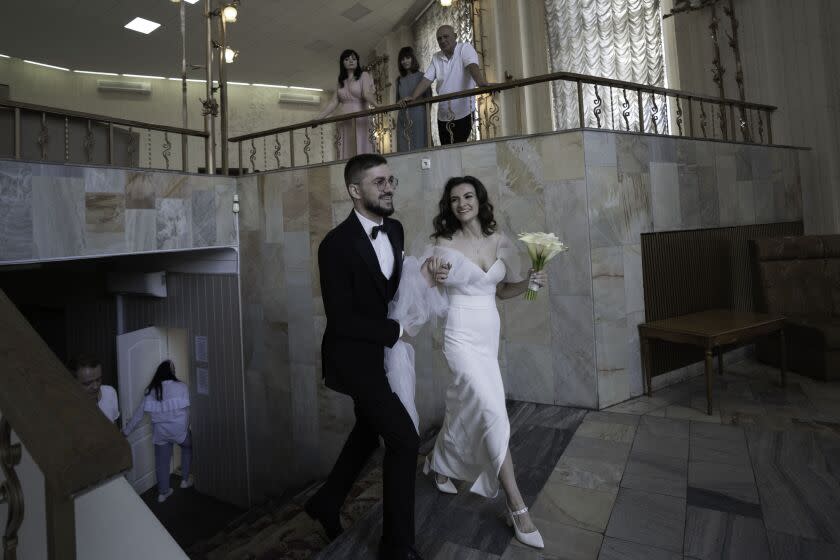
583, 131, 810, 408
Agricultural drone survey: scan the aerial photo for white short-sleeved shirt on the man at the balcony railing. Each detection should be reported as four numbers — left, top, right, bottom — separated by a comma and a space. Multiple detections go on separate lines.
424, 43, 478, 121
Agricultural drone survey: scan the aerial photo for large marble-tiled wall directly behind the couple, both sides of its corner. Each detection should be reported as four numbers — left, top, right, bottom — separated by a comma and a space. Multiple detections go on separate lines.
239, 131, 808, 495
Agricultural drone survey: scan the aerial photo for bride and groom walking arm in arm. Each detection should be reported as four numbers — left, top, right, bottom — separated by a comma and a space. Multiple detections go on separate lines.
305, 154, 546, 560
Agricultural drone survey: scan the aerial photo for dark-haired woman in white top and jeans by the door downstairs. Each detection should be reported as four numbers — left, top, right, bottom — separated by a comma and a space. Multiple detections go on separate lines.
123, 360, 192, 502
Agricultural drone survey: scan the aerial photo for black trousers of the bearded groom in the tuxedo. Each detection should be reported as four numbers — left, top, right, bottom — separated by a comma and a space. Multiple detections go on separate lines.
313, 375, 420, 557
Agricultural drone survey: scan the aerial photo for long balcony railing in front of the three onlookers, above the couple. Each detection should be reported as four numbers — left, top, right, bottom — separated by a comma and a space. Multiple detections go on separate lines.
230, 72, 776, 171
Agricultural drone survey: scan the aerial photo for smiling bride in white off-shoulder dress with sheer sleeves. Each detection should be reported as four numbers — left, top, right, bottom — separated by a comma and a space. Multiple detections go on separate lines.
386, 176, 546, 548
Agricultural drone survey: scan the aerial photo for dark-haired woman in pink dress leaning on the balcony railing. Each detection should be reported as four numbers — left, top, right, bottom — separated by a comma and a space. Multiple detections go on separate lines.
317, 49, 377, 159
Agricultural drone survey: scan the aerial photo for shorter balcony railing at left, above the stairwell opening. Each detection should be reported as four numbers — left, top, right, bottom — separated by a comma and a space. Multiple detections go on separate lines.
0, 100, 208, 171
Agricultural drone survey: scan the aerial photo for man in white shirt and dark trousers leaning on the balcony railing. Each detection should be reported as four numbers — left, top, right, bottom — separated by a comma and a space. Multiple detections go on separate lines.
405, 25, 490, 144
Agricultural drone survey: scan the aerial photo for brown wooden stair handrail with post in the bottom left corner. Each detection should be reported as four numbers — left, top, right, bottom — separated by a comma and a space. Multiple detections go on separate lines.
0, 290, 132, 559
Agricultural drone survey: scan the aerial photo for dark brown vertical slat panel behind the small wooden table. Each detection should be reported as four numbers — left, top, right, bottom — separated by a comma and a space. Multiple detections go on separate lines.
642, 222, 803, 375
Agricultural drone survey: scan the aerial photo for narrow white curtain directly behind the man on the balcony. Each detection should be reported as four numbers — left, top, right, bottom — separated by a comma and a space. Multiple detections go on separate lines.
411, 0, 475, 145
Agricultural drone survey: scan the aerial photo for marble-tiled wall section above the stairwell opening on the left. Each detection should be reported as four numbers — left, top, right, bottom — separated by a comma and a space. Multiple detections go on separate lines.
0, 160, 238, 263
